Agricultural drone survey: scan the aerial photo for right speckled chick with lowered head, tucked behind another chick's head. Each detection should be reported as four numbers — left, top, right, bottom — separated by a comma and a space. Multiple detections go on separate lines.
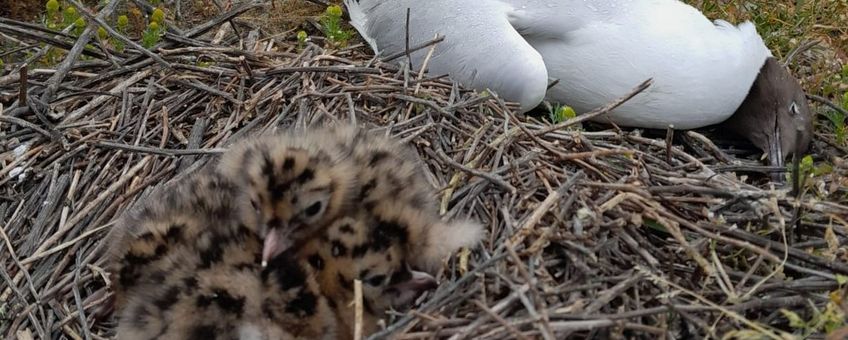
299, 128, 482, 337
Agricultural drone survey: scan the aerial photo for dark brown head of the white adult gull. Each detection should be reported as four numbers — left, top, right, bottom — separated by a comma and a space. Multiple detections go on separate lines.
725, 57, 813, 175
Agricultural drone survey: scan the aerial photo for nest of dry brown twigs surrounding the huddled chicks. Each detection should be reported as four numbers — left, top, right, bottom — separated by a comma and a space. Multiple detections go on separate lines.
0, 1, 848, 339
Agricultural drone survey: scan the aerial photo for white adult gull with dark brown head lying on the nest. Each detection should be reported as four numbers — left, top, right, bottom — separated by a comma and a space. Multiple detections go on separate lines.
345, 0, 813, 165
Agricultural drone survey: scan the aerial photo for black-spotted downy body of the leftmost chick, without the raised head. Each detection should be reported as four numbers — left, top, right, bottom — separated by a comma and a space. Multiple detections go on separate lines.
108, 168, 336, 339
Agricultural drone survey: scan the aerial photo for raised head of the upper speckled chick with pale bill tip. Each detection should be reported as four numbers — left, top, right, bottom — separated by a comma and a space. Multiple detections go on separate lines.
219, 130, 355, 265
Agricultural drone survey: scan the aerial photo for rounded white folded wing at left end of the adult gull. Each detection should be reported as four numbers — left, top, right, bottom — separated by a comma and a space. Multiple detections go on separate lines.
345, 0, 548, 111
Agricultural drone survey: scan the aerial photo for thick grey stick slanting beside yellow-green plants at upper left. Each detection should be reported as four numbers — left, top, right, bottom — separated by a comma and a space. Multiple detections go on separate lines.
41, 0, 124, 110
